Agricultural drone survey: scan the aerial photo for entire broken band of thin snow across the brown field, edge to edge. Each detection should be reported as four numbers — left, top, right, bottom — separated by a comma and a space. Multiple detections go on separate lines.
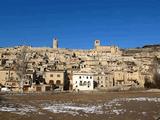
0, 97, 160, 116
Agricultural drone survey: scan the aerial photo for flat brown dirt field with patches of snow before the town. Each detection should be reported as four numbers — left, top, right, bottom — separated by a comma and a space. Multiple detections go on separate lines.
0, 91, 160, 120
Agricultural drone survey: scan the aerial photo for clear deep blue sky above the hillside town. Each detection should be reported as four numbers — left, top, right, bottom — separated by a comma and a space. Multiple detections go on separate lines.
0, 0, 160, 49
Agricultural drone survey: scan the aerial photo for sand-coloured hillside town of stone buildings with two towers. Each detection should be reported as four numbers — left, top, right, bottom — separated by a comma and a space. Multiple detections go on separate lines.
0, 39, 160, 92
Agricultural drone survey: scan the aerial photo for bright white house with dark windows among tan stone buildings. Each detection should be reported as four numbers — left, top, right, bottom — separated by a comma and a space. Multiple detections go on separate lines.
73, 73, 94, 91
